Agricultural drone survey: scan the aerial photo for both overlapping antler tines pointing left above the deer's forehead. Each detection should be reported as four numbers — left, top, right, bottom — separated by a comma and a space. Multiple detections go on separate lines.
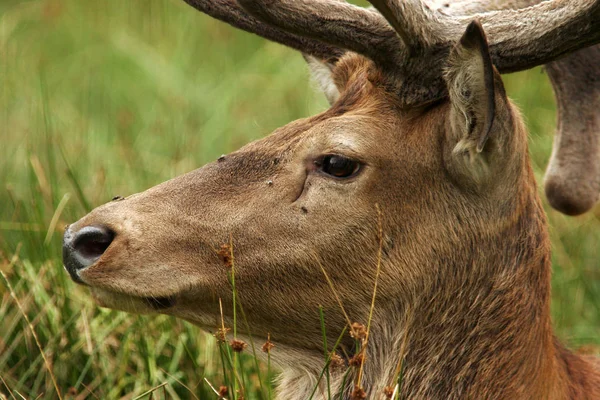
184, 0, 402, 65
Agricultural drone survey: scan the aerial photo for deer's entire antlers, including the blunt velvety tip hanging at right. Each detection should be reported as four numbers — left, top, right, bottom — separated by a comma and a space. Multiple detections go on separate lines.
185, 0, 600, 214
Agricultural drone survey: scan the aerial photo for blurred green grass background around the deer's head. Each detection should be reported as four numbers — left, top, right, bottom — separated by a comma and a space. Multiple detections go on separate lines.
0, 0, 600, 399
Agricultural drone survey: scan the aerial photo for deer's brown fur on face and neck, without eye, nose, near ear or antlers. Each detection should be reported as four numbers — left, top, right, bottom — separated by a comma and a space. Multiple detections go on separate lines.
62, 48, 600, 400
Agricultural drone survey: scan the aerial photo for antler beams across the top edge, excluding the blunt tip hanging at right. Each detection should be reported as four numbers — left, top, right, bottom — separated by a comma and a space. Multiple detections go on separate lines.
185, 0, 600, 106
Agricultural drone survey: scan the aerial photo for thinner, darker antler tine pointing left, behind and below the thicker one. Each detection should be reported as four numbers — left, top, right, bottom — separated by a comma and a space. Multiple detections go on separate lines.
184, 0, 346, 60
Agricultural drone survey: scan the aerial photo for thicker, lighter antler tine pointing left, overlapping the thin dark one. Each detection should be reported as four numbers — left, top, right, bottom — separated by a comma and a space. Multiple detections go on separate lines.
238, 0, 404, 66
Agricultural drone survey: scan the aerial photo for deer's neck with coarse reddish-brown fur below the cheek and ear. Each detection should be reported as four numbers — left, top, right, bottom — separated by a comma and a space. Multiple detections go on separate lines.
380, 194, 560, 399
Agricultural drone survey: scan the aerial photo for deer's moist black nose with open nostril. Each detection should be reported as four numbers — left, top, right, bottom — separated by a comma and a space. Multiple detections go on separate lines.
63, 226, 115, 283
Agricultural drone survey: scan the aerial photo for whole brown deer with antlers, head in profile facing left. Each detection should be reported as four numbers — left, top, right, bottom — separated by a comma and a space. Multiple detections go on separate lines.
63, 0, 600, 400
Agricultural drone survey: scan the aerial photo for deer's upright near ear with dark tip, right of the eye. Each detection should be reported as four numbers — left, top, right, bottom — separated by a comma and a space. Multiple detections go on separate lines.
445, 21, 512, 188
